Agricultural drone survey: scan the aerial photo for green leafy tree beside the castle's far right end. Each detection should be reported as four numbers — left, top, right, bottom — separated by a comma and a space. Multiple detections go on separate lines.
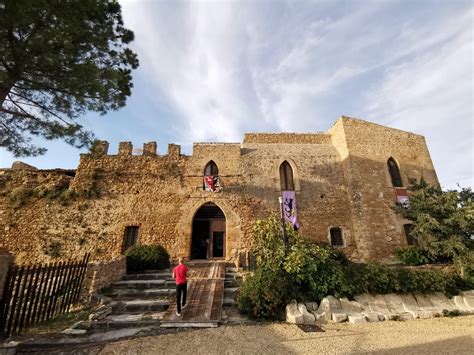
397, 180, 474, 273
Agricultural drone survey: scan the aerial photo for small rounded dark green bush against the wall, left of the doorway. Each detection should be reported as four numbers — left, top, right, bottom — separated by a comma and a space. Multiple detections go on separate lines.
125, 245, 170, 272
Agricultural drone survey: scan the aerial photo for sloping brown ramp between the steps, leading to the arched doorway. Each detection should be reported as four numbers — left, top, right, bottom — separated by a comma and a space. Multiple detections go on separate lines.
161, 262, 225, 327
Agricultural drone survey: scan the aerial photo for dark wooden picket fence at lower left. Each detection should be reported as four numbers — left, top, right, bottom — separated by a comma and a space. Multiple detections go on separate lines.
0, 254, 90, 338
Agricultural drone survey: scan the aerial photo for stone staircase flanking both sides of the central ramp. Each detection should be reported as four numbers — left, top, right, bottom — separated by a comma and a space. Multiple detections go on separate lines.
79, 264, 241, 330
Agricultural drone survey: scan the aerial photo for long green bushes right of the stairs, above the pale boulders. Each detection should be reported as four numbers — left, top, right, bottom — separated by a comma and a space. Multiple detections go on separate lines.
237, 216, 474, 318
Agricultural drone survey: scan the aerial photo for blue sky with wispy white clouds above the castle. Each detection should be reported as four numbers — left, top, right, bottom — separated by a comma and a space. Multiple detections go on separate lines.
0, 0, 474, 188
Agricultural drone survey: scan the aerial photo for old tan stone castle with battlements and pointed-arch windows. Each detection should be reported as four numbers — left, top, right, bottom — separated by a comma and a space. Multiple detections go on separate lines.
0, 117, 439, 265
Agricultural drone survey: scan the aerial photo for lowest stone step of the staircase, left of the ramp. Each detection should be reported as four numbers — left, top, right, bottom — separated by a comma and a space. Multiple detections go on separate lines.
81, 312, 165, 330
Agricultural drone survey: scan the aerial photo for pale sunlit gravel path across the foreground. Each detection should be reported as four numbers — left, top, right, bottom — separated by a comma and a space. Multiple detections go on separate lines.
90, 316, 474, 354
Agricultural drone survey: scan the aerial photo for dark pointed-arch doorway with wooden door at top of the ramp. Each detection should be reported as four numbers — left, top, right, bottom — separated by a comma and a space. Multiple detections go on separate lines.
191, 202, 225, 259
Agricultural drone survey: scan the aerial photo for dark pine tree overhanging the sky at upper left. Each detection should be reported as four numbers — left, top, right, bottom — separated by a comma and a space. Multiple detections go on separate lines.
0, 0, 138, 156
